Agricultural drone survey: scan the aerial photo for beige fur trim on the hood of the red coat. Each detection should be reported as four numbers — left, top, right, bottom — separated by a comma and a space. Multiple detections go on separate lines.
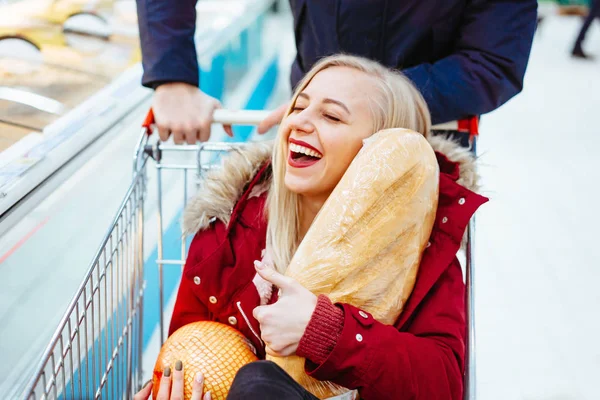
183, 135, 479, 235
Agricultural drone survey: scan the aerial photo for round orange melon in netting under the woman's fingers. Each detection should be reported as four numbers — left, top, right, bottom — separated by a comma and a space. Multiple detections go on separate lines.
152, 321, 258, 400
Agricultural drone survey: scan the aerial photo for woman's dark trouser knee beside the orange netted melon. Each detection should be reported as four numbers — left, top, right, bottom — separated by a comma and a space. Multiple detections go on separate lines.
227, 361, 318, 400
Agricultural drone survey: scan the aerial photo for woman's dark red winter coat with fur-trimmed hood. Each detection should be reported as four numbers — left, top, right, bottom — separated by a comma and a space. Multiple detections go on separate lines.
169, 137, 487, 400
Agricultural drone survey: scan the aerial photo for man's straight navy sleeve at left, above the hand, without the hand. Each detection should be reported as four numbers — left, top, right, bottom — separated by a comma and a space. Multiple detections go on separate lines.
136, 0, 200, 88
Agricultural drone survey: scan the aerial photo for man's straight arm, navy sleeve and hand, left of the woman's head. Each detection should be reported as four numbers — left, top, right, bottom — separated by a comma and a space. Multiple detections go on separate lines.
136, 0, 233, 144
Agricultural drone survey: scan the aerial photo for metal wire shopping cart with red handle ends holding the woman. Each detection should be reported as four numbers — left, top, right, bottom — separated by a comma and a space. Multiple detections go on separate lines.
24, 110, 477, 400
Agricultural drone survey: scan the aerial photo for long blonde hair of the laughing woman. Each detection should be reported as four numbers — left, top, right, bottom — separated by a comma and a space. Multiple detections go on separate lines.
266, 55, 431, 272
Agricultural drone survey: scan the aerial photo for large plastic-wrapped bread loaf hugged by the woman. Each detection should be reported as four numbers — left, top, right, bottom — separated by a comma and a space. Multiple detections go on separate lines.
267, 129, 439, 399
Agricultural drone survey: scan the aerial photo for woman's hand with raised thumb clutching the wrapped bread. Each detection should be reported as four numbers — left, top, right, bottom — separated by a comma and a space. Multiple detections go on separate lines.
253, 261, 317, 357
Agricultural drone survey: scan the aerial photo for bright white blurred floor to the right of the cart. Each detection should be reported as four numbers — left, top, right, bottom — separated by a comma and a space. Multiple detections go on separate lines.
476, 17, 600, 400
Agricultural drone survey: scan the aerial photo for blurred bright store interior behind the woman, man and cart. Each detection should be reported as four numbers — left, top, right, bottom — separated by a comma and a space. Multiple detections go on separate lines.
0, 0, 600, 400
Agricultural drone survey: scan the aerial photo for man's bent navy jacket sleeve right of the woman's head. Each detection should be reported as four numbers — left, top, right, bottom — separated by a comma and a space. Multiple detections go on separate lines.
404, 0, 537, 124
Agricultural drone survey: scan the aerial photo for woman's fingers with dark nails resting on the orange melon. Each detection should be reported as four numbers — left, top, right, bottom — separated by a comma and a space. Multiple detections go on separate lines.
133, 361, 211, 400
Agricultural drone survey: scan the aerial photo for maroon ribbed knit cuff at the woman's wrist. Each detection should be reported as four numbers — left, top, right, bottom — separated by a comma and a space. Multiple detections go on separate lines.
296, 295, 344, 364
